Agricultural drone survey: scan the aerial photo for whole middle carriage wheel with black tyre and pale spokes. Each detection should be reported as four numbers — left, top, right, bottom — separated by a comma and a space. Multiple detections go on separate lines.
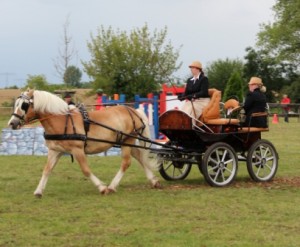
202, 142, 238, 187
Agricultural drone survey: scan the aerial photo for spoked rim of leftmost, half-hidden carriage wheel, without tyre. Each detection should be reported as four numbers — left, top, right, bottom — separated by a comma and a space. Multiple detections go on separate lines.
161, 160, 191, 180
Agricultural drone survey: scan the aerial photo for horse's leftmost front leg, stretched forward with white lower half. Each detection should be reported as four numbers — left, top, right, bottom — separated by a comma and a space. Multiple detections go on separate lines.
33, 149, 63, 197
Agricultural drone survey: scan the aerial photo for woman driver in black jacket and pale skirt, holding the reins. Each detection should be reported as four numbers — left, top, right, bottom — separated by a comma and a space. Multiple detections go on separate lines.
178, 61, 210, 119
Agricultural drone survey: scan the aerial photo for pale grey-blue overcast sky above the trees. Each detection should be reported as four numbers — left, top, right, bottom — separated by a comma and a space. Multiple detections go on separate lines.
0, 0, 276, 88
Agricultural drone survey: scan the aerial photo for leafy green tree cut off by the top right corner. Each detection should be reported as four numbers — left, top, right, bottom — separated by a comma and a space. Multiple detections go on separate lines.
258, 0, 300, 66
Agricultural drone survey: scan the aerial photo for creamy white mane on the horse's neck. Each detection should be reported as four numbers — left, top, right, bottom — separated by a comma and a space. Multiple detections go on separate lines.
33, 90, 69, 115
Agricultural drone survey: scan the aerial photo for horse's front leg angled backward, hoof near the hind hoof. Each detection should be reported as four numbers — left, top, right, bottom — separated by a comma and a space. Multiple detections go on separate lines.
72, 149, 108, 194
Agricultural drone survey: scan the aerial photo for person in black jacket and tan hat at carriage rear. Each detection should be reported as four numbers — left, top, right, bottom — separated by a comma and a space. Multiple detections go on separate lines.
243, 77, 268, 128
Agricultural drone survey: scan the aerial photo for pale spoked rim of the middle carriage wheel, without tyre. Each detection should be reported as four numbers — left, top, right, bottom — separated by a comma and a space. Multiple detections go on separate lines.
206, 147, 237, 186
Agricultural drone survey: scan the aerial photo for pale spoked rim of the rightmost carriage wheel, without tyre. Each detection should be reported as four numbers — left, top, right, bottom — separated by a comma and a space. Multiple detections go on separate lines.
250, 143, 277, 181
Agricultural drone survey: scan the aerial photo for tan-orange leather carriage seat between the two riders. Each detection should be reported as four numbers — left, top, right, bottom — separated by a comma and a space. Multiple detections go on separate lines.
200, 88, 239, 125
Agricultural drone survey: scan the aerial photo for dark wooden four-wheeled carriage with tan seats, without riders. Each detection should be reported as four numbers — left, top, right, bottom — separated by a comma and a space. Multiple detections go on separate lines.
154, 89, 278, 187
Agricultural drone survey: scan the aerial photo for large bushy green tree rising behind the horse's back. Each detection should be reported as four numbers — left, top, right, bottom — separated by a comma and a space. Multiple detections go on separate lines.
83, 24, 181, 99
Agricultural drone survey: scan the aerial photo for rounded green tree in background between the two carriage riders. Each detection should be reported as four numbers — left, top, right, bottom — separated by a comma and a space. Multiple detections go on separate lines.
206, 58, 243, 92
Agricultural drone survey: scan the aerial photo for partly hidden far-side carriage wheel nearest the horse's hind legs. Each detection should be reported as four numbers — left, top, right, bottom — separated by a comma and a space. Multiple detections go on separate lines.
159, 160, 192, 181
